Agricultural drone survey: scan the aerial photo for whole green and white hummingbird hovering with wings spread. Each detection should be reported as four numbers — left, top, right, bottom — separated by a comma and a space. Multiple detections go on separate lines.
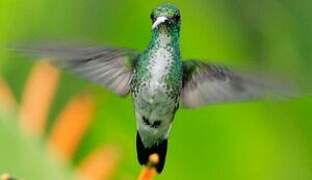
14, 3, 292, 173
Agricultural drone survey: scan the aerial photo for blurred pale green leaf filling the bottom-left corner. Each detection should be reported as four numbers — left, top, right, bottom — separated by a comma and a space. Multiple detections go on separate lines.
0, 111, 73, 180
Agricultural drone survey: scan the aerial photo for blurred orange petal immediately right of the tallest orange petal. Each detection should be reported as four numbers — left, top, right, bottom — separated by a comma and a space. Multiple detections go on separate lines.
48, 94, 95, 159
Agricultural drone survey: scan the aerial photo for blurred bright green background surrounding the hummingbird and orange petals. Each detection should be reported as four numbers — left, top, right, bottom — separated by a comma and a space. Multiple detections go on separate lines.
0, 0, 312, 180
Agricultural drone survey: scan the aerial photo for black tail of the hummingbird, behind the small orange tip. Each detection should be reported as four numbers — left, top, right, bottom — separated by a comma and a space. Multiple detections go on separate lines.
136, 132, 168, 173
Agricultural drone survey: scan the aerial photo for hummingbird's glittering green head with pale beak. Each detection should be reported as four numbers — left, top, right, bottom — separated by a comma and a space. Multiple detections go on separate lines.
151, 3, 181, 31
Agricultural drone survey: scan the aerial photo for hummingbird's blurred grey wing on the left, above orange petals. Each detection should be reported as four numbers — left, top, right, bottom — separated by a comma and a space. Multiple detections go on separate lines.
17, 46, 139, 96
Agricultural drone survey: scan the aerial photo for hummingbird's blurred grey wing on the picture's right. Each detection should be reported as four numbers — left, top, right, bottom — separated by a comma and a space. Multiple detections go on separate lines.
181, 60, 292, 108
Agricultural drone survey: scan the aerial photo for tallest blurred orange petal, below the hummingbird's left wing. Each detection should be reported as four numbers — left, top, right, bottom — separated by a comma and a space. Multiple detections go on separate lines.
20, 61, 59, 135
